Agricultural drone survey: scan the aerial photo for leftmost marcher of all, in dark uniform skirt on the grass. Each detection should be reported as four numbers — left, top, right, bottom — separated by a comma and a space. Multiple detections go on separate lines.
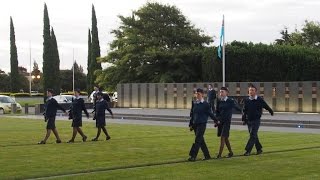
38, 89, 68, 144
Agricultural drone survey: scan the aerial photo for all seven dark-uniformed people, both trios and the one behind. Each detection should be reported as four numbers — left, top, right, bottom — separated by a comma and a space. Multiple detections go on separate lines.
38, 85, 273, 161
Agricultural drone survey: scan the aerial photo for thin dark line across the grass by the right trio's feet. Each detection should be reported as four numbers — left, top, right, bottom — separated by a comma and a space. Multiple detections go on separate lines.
28, 146, 320, 179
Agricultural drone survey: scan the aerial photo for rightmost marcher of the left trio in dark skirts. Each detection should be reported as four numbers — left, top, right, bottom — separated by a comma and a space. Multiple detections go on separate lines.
92, 92, 113, 141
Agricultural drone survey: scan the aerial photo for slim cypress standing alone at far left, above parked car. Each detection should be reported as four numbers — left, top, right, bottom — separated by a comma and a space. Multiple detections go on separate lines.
10, 17, 20, 92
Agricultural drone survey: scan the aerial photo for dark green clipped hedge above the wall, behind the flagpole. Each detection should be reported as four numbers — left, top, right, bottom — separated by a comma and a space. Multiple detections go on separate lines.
202, 41, 320, 82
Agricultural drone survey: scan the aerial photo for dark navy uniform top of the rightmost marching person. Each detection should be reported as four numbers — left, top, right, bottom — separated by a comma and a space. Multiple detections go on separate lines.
243, 96, 273, 121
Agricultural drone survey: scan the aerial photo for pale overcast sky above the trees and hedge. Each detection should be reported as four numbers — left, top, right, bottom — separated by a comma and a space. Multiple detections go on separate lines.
0, 0, 320, 72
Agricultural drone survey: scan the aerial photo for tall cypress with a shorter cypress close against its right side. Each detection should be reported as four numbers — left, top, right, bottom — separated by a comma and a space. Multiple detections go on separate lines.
42, 4, 55, 98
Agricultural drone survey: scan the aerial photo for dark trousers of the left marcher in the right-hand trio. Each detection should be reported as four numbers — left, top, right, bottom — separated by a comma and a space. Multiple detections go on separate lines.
189, 123, 210, 157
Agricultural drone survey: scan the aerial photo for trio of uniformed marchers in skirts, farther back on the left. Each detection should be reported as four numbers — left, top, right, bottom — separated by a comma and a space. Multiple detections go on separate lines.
38, 89, 113, 144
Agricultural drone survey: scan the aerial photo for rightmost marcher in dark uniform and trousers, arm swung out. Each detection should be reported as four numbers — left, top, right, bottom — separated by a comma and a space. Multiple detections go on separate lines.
242, 85, 273, 156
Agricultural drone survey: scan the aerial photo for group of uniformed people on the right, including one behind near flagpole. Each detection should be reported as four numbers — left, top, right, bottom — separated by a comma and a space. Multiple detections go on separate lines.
188, 85, 273, 161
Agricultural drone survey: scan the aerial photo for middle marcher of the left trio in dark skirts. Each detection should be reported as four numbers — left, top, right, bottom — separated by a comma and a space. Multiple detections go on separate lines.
68, 89, 89, 143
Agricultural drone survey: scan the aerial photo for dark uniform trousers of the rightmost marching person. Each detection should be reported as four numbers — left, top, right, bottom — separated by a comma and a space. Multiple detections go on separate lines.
246, 119, 262, 152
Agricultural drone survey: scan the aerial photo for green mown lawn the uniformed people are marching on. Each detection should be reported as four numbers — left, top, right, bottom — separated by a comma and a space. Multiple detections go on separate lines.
0, 117, 320, 179
